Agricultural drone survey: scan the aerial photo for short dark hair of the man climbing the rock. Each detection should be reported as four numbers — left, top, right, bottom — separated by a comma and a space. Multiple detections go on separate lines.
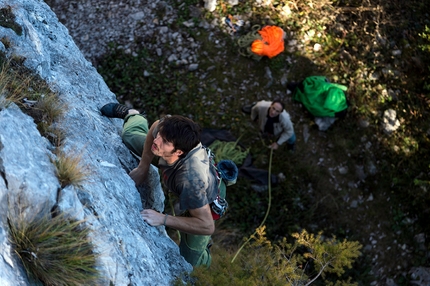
158, 115, 201, 157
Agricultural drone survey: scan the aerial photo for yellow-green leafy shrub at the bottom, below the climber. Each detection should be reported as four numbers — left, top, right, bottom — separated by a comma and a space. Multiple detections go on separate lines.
192, 226, 361, 285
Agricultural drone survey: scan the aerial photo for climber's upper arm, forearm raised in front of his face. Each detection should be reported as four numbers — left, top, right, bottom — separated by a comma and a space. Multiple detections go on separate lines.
129, 120, 159, 186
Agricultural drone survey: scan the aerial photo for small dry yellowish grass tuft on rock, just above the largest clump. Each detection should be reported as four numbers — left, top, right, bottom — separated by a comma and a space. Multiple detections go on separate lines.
53, 151, 90, 188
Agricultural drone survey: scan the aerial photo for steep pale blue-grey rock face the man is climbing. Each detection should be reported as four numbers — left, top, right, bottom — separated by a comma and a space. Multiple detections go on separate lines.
0, 0, 192, 286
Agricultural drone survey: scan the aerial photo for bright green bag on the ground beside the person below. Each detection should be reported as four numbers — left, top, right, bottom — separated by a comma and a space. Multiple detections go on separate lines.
293, 76, 348, 117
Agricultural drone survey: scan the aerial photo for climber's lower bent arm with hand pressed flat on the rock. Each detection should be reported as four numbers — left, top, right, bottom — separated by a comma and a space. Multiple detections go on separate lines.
141, 204, 215, 235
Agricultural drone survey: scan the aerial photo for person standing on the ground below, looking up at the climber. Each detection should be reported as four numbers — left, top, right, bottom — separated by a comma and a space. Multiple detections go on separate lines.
242, 99, 296, 151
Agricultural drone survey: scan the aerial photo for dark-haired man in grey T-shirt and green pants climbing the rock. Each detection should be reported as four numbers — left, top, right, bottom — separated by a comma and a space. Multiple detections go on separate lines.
101, 103, 226, 266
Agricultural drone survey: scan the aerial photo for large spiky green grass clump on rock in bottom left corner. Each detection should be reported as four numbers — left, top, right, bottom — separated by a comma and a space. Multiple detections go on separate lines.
7, 211, 99, 286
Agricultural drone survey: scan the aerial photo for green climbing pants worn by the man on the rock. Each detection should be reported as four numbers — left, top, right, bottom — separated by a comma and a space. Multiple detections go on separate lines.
121, 114, 226, 267
